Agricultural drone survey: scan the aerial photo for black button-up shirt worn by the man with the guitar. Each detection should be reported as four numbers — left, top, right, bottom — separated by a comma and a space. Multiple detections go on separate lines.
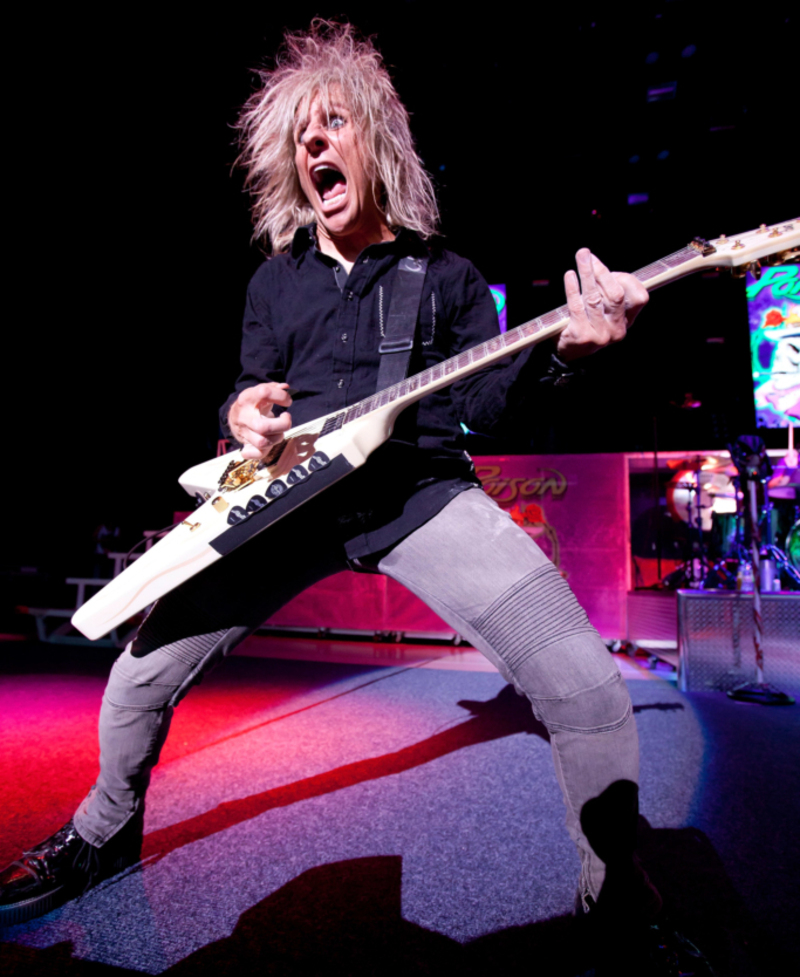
220, 225, 546, 559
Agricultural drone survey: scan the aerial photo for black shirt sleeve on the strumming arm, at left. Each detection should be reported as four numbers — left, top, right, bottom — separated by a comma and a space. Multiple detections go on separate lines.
219, 262, 286, 441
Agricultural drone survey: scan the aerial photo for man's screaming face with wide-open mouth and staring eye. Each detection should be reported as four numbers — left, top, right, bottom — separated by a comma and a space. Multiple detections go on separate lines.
294, 93, 385, 246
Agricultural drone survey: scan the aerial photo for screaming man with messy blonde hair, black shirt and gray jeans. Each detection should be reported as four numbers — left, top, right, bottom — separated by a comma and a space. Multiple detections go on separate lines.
0, 24, 659, 936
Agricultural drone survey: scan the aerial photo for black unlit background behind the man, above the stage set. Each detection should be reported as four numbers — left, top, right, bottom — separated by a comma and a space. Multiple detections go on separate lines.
2, 0, 800, 579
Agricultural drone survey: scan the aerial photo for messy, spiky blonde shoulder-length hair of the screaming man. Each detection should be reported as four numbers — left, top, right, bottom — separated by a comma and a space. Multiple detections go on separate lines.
237, 20, 439, 252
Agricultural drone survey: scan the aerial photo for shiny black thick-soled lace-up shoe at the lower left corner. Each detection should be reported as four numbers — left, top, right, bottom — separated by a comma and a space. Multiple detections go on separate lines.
0, 815, 142, 926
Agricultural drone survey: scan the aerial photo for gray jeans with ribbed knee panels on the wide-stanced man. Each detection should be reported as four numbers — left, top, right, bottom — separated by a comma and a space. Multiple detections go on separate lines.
75, 489, 639, 898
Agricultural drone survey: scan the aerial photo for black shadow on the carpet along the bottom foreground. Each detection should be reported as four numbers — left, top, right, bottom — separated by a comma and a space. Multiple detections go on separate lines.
3, 819, 768, 977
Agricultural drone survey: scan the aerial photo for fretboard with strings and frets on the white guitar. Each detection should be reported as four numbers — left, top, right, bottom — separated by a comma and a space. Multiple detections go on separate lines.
318, 245, 698, 435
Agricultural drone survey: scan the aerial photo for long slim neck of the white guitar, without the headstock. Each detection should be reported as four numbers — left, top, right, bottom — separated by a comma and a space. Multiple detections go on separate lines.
308, 242, 714, 434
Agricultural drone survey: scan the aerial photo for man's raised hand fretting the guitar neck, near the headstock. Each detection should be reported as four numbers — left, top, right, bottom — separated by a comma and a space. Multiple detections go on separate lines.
557, 248, 650, 362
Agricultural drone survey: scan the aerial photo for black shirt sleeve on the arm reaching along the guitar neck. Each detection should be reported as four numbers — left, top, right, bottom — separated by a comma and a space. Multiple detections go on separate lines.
441, 252, 554, 435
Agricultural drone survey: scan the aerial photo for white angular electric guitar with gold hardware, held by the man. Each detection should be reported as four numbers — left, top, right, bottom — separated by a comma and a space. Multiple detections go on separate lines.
72, 218, 800, 640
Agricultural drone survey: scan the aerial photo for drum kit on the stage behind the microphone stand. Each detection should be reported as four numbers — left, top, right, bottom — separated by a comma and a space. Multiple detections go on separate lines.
663, 438, 800, 592
